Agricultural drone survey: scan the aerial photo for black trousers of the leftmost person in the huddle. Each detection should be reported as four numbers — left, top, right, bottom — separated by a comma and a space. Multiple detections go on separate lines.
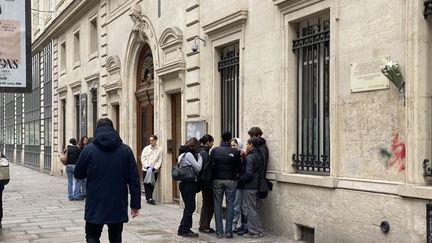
178, 181, 197, 233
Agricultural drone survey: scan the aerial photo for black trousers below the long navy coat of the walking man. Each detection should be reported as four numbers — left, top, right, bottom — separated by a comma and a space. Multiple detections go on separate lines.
86, 222, 123, 243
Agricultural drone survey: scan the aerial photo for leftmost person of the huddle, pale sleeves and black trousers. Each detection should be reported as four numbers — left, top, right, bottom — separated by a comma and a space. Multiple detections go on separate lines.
177, 137, 203, 237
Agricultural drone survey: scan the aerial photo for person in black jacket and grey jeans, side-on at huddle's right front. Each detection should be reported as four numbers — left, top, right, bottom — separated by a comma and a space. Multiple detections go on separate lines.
238, 137, 263, 238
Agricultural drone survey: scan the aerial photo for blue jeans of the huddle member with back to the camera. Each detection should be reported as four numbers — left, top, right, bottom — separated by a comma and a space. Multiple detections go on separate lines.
213, 180, 237, 234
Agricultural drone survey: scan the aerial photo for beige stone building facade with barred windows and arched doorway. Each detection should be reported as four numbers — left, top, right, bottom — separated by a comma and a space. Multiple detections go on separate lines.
3, 0, 432, 242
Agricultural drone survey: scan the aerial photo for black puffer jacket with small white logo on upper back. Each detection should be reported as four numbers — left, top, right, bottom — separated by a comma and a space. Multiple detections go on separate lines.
210, 142, 241, 180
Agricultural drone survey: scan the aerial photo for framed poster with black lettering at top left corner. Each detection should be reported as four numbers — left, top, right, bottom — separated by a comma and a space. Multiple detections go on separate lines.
0, 0, 31, 93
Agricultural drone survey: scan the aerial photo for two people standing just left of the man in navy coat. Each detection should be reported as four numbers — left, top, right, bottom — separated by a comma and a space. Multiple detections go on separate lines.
66, 136, 90, 201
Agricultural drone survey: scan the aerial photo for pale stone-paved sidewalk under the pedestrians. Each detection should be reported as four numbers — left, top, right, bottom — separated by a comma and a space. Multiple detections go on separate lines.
0, 163, 298, 243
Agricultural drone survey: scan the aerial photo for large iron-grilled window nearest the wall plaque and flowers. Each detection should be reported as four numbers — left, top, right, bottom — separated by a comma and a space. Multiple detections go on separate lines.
293, 18, 330, 174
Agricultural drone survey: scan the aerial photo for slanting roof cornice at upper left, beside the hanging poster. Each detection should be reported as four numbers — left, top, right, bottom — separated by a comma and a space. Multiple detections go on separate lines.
32, 0, 99, 53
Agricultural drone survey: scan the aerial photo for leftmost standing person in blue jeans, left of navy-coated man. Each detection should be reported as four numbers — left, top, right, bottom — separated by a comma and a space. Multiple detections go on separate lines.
66, 138, 83, 201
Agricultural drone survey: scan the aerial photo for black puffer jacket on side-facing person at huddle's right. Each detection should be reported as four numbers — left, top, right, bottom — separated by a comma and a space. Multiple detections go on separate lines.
237, 148, 261, 190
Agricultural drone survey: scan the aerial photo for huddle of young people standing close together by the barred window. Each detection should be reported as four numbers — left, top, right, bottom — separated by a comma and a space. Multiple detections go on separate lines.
178, 127, 269, 238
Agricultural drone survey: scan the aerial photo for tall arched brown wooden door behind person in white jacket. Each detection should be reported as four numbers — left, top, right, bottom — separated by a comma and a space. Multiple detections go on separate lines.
135, 43, 155, 178
